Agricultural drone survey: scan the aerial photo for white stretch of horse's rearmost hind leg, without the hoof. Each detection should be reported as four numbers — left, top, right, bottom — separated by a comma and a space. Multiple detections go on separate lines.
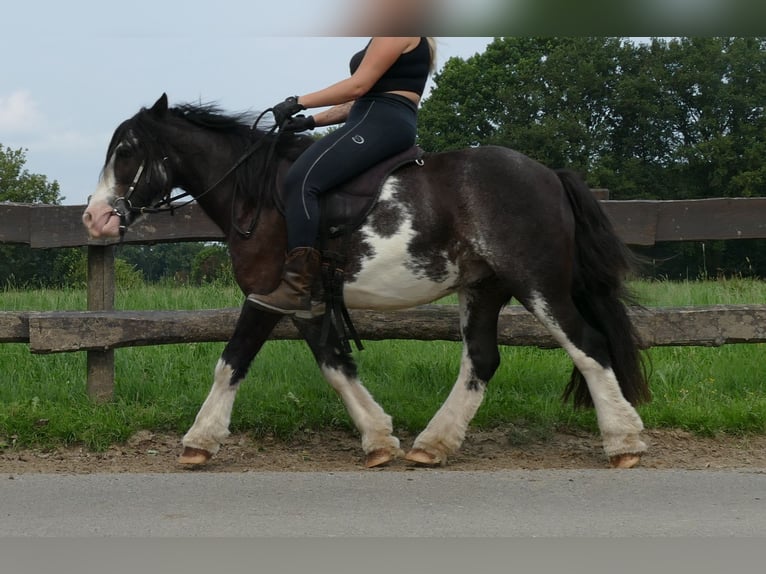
530, 293, 646, 456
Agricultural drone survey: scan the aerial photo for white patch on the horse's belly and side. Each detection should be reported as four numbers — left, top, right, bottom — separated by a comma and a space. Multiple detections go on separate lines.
343, 176, 458, 309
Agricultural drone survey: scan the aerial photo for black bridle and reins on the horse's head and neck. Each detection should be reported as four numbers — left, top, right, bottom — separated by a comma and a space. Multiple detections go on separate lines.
112, 108, 281, 241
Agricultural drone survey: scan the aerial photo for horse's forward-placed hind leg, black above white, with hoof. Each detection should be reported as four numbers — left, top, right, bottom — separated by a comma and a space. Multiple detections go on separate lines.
405, 290, 509, 466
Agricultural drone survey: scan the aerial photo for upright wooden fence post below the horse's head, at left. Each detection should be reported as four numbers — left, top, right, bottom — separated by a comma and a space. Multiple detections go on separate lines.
86, 245, 114, 402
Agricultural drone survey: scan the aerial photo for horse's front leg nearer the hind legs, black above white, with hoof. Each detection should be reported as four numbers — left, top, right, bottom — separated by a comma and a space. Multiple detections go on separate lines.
294, 318, 403, 468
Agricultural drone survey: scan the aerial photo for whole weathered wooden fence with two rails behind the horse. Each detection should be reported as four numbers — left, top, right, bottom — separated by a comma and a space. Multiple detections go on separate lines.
0, 198, 766, 399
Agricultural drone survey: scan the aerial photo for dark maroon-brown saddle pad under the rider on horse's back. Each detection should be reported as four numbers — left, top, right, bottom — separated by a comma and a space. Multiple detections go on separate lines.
275, 146, 425, 242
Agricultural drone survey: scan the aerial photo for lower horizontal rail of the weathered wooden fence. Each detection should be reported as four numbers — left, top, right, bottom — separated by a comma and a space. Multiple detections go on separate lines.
0, 305, 766, 353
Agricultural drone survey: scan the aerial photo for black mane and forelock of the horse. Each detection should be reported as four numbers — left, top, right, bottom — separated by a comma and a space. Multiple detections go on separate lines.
106, 103, 313, 212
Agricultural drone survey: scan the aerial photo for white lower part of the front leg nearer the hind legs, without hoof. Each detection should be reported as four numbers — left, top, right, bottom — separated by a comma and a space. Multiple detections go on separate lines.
322, 365, 399, 453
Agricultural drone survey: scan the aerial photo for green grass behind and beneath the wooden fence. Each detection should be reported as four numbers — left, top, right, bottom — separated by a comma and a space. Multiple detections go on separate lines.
0, 279, 766, 450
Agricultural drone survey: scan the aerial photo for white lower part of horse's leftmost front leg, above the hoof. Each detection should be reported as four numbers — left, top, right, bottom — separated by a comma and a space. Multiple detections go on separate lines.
181, 359, 239, 460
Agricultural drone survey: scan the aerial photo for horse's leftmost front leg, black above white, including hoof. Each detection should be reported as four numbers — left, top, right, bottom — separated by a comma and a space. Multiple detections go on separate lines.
178, 303, 282, 466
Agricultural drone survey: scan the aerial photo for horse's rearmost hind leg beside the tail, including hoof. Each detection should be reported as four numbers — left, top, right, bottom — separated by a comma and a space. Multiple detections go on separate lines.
527, 294, 646, 468
